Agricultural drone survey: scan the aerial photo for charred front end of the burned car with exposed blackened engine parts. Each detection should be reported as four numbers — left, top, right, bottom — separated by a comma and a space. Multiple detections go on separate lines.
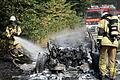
47, 42, 91, 72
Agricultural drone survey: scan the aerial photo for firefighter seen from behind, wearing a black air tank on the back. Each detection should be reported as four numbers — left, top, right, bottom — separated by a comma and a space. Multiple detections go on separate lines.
97, 12, 119, 80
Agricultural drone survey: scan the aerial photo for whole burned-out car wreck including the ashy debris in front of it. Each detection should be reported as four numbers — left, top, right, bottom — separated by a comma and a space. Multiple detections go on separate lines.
32, 30, 98, 80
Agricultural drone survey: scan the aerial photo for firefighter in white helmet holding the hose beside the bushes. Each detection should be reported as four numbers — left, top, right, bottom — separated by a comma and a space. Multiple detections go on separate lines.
3, 16, 23, 58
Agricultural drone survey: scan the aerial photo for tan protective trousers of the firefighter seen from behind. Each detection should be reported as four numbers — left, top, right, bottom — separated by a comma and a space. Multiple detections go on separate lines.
99, 46, 116, 79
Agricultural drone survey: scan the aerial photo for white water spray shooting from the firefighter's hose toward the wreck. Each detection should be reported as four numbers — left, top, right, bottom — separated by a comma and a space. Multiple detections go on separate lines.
14, 36, 45, 61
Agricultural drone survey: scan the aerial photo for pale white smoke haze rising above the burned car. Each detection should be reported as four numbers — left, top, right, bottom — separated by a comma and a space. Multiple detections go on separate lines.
51, 27, 87, 47
